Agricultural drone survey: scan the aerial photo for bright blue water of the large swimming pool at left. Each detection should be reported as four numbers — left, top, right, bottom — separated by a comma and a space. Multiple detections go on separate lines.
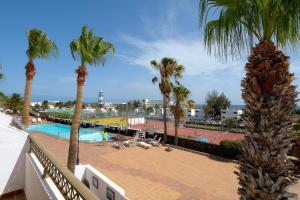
27, 124, 110, 142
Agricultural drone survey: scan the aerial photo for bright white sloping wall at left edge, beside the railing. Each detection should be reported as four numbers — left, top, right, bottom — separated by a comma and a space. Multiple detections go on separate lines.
0, 123, 29, 194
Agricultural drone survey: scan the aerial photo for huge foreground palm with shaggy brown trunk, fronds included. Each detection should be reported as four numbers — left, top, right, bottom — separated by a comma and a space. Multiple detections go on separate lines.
200, 0, 300, 200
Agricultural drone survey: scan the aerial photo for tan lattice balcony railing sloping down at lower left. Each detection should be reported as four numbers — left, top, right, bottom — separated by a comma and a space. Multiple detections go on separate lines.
29, 135, 99, 200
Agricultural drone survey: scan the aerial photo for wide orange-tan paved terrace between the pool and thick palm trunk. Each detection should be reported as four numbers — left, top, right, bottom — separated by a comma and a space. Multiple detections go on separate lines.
33, 133, 238, 200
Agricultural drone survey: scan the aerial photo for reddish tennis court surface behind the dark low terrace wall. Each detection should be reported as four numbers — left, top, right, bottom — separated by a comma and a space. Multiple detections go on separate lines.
131, 121, 244, 144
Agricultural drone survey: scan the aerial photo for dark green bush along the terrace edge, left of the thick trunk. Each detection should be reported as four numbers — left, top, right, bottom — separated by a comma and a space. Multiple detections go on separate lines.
220, 140, 242, 158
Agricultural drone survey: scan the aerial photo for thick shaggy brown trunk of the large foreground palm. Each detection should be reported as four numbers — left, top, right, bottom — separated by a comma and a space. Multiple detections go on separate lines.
237, 41, 297, 200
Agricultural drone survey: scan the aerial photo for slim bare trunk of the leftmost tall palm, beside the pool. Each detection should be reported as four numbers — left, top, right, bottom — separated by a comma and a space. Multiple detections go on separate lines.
22, 61, 35, 125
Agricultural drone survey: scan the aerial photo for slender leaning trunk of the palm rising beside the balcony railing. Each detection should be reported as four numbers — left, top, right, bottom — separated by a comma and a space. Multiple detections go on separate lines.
68, 66, 87, 173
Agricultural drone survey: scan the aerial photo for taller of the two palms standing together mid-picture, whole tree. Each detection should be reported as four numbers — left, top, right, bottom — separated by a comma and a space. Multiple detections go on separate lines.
151, 58, 184, 144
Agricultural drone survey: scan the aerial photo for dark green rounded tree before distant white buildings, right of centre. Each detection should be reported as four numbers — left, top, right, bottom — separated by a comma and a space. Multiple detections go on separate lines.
204, 90, 230, 118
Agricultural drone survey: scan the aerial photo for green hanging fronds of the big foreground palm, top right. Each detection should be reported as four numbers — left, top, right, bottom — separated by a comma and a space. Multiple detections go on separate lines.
199, 0, 300, 58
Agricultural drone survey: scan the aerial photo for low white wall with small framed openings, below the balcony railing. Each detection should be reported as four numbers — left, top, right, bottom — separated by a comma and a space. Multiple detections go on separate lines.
75, 165, 128, 200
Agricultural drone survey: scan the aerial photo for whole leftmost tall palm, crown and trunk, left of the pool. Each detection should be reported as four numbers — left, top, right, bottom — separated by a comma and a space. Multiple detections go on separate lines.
22, 29, 58, 125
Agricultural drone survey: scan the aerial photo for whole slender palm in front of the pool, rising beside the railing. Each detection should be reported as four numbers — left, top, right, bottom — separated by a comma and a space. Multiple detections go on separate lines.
68, 26, 114, 173
